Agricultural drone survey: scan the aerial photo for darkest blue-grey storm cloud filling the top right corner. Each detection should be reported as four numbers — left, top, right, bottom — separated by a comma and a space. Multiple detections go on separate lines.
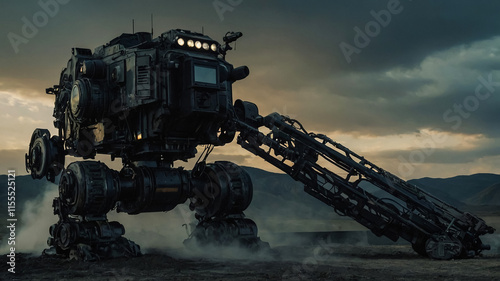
332, 0, 500, 70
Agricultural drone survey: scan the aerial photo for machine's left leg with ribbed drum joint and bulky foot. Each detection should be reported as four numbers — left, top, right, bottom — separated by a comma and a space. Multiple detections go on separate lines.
45, 161, 141, 261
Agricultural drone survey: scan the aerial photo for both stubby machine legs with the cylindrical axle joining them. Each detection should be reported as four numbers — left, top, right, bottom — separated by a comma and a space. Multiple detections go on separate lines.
42, 161, 269, 261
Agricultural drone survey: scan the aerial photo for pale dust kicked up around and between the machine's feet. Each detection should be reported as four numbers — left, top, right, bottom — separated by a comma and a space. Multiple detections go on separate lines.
0, 180, 368, 260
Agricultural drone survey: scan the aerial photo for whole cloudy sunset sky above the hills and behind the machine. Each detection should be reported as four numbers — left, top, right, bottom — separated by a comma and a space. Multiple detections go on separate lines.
0, 0, 500, 179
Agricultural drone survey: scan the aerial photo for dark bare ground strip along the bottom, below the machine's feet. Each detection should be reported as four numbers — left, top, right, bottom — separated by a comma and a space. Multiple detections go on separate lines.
0, 243, 500, 280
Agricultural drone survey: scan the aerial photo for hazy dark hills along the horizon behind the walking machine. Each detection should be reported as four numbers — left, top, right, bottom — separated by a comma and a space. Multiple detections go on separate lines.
0, 167, 500, 228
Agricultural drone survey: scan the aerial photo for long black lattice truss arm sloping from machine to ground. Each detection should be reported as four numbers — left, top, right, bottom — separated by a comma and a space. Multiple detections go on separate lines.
238, 113, 494, 259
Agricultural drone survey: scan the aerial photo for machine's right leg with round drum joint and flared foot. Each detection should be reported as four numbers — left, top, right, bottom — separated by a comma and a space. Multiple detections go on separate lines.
184, 161, 269, 250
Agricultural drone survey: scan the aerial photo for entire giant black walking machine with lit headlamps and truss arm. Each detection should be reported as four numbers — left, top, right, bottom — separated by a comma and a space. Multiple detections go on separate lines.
26, 29, 495, 260
